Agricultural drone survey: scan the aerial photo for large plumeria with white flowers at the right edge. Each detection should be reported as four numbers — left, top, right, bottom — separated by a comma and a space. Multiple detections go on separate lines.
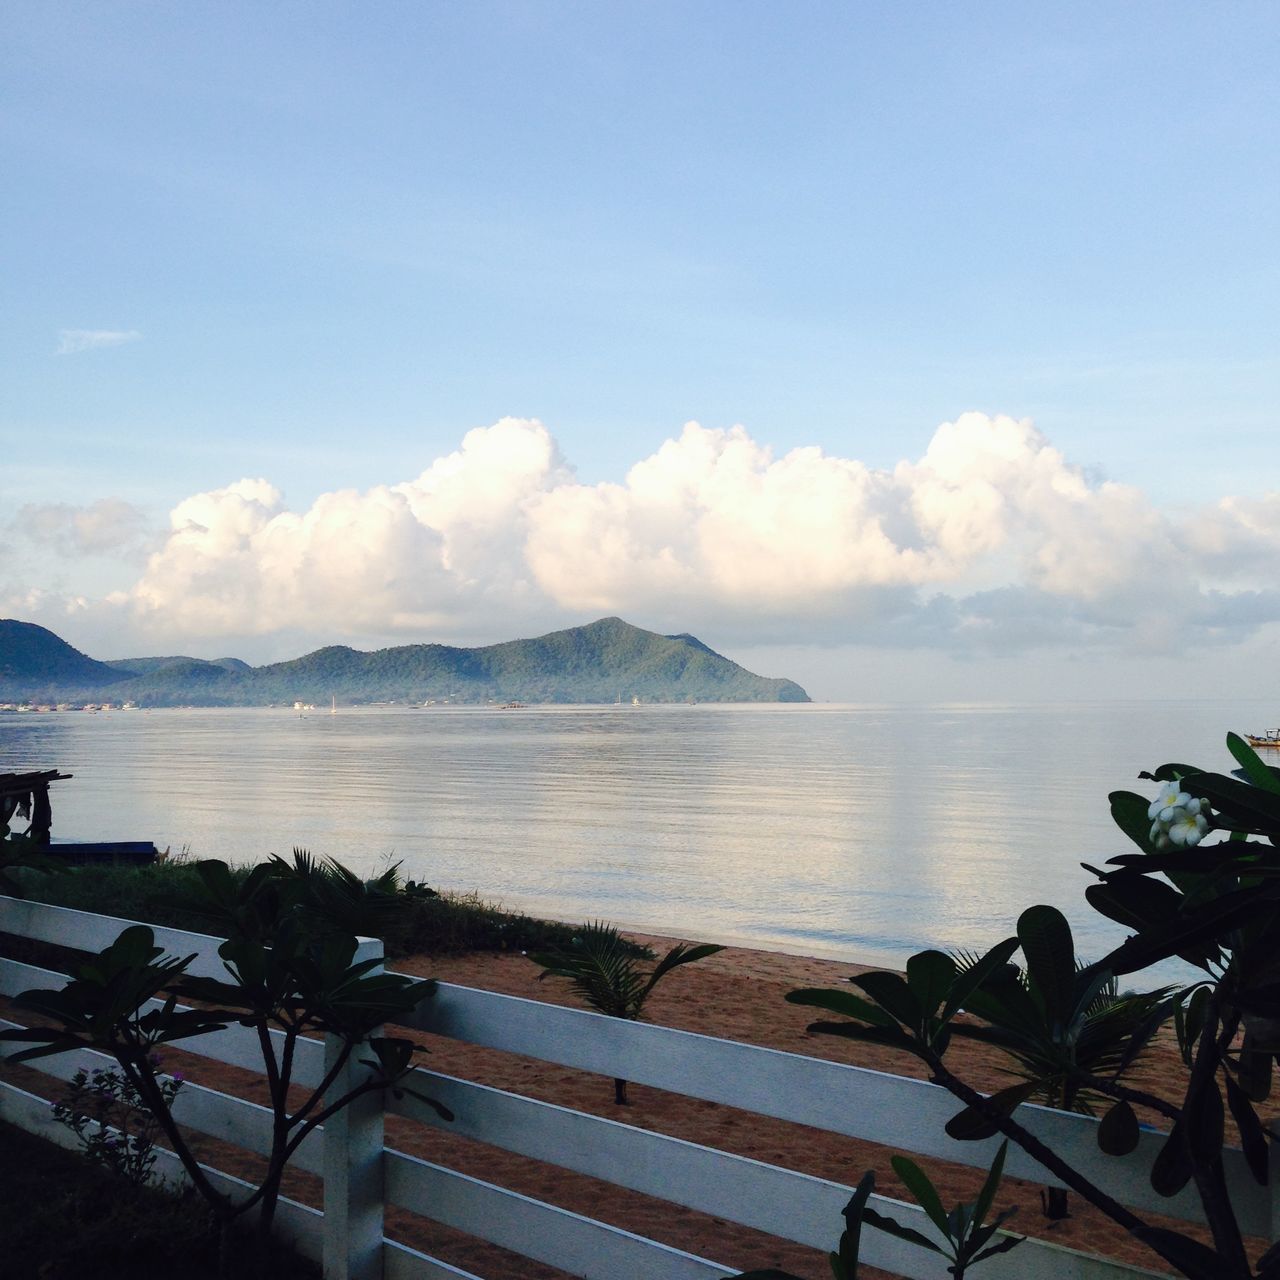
787, 733, 1280, 1280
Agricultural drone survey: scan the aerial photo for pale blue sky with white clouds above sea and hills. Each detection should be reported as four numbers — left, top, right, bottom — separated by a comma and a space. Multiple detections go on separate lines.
0, 0, 1280, 701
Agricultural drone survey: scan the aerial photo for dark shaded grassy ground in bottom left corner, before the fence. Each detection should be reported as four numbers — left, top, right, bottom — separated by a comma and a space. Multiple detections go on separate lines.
0, 1123, 320, 1280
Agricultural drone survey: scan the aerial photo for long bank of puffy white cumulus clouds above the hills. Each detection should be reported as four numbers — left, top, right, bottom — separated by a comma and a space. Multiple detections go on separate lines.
9, 412, 1280, 653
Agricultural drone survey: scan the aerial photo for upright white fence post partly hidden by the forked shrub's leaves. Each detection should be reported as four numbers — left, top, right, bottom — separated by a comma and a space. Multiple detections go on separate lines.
324, 938, 383, 1280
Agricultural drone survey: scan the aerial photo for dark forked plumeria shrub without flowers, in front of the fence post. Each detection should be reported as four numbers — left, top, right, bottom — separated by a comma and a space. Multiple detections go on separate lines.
0, 860, 449, 1275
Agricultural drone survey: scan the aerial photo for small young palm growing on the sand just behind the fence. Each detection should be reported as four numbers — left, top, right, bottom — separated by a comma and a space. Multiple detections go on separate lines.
529, 920, 724, 1107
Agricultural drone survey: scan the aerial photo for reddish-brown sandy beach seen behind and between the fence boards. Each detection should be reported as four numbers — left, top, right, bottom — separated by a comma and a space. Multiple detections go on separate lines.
5, 933, 1213, 1280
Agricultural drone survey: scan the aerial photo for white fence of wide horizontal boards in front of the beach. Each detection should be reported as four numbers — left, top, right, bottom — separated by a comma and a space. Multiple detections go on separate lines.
0, 897, 1244, 1280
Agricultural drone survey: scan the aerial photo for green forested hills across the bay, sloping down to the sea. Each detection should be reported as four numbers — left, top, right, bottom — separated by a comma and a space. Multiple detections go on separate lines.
0, 618, 809, 707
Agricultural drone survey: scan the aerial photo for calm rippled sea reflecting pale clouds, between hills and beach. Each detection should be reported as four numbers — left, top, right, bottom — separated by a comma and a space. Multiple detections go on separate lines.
0, 703, 1259, 963
